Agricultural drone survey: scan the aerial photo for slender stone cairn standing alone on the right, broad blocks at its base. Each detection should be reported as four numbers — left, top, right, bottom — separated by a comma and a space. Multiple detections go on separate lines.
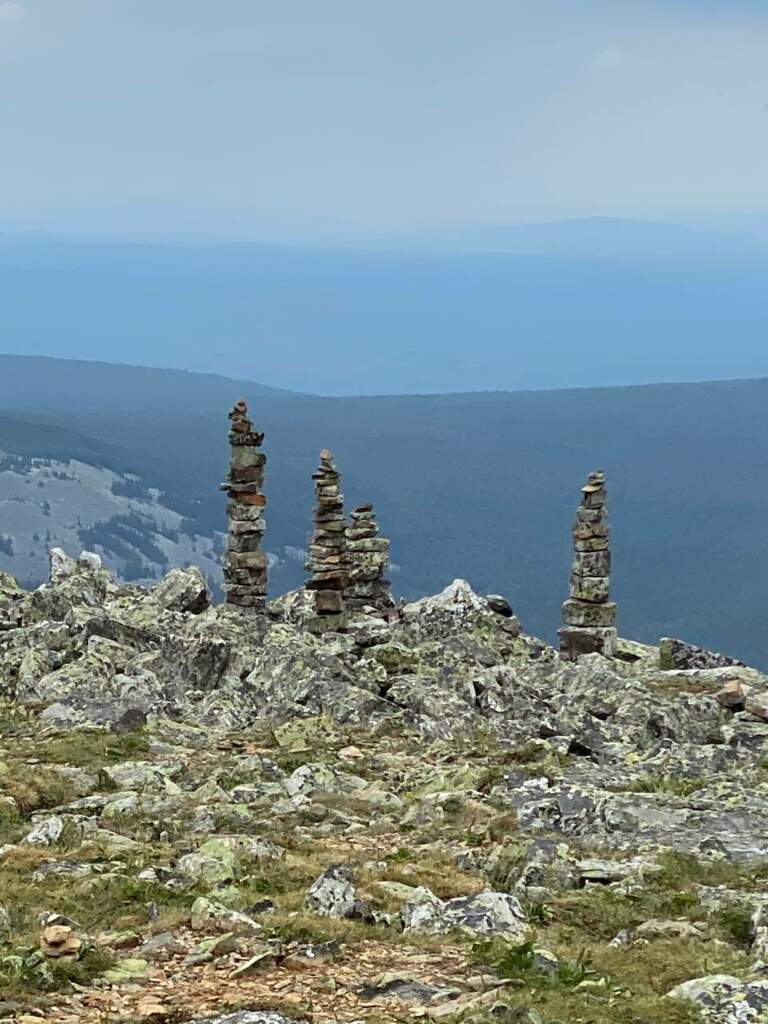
559, 470, 617, 660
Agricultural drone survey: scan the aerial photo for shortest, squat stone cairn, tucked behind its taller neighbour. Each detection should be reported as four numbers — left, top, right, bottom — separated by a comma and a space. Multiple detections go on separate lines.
344, 505, 394, 614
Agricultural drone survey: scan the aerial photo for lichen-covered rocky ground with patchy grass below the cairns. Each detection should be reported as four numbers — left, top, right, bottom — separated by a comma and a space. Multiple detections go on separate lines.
0, 555, 768, 1024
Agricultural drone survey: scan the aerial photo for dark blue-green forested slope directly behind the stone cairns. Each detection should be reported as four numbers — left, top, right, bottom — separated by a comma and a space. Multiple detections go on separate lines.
0, 360, 768, 666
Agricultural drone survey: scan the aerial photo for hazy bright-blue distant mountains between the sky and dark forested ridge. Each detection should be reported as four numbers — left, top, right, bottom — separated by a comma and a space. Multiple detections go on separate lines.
0, 221, 768, 394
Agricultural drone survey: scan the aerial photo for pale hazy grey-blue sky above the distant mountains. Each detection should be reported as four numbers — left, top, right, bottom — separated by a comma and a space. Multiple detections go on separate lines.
0, 0, 768, 238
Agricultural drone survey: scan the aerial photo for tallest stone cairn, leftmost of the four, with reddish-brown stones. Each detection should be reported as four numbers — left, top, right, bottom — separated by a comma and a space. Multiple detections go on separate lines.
221, 398, 267, 615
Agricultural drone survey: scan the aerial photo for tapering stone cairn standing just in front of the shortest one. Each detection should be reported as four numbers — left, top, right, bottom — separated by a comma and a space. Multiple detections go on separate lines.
305, 449, 348, 633
